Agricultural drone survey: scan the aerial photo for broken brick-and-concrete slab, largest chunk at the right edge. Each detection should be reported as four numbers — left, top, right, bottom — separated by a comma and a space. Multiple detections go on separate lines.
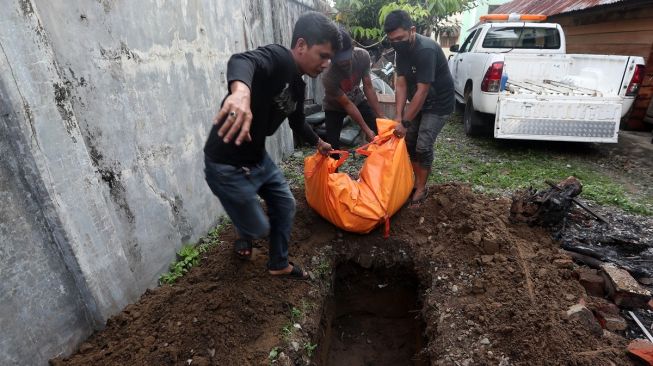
601, 264, 651, 308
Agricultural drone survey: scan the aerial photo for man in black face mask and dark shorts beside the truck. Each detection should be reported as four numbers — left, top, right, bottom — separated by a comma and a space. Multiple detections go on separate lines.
384, 10, 454, 206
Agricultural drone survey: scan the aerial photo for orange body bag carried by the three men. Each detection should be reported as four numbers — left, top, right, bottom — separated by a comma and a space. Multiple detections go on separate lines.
304, 119, 413, 237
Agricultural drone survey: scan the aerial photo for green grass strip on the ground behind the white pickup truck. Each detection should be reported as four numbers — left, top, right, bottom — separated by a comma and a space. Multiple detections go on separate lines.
429, 115, 653, 215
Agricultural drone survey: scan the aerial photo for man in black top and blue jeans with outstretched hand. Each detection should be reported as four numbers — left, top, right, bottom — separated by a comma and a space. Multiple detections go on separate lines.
204, 12, 341, 279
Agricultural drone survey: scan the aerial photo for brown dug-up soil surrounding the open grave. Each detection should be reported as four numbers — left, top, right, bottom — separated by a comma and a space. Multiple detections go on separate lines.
52, 184, 632, 366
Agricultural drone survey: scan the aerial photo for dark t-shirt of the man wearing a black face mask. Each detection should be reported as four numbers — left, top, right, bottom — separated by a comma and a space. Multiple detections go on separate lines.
397, 34, 455, 116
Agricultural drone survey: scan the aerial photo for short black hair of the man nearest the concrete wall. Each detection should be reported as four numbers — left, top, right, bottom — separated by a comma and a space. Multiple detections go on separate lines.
290, 11, 342, 52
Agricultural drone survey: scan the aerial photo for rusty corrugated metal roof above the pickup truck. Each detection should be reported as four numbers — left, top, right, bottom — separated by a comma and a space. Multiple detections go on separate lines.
492, 0, 627, 15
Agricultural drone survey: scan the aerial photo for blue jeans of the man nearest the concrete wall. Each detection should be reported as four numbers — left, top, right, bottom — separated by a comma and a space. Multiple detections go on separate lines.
204, 153, 295, 270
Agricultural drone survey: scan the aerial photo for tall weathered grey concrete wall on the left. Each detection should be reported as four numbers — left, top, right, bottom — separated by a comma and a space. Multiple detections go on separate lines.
0, 0, 323, 365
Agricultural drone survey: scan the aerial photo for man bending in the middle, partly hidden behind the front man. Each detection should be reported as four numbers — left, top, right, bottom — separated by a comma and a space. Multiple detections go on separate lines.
322, 28, 383, 149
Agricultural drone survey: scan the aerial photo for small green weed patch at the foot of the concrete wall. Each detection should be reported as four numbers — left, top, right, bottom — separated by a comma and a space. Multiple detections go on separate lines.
159, 216, 230, 285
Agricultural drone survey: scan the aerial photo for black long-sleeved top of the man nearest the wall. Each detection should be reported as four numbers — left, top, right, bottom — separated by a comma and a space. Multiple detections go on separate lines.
204, 44, 318, 166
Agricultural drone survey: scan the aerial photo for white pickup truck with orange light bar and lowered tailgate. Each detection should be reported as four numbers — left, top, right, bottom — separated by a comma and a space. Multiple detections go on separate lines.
449, 14, 644, 143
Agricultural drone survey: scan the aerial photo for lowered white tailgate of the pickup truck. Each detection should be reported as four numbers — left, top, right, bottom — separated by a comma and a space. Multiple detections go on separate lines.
494, 96, 622, 143
